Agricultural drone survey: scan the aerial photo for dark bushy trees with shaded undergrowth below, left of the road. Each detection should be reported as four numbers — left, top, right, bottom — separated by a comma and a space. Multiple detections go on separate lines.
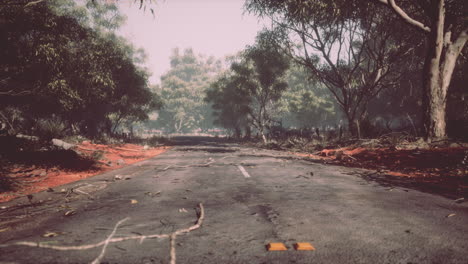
0, 0, 162, 192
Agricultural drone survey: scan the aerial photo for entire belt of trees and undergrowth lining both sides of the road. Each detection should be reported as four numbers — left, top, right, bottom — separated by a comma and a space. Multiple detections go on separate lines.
0, 0, 468, 200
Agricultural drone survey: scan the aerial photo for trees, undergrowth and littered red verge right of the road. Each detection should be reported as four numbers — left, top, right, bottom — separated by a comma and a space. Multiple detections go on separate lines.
207, 0, 468, 196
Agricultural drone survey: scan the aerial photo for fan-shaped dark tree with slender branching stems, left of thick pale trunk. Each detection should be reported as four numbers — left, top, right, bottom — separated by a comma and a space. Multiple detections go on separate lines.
247, 0, 412, 136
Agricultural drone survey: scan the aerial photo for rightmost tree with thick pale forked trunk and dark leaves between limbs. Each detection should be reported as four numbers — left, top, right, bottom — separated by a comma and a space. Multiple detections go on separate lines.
379, 0, 468, 140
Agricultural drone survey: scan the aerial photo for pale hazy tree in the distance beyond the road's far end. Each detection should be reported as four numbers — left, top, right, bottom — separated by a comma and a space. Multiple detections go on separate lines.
157, 49, 220, 133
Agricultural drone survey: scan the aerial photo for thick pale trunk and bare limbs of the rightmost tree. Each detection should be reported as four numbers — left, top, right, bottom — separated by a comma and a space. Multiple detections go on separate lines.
379, 0, 468, 141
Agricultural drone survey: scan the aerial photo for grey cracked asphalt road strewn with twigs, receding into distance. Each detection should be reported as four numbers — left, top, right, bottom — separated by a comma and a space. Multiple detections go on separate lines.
0, 138, 468, 264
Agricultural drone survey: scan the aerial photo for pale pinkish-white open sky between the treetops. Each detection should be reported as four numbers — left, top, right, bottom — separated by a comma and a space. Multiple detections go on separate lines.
119, 0, 264, 84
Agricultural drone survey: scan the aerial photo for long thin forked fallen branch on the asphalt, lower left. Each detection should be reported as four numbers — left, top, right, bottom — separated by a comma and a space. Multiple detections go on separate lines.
0, 203, 205, 264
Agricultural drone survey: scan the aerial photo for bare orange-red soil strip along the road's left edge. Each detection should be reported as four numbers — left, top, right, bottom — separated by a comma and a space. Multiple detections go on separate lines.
0, 141, 169, 202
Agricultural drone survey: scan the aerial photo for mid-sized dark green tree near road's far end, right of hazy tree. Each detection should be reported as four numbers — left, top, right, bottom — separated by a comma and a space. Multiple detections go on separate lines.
208, 32, 289, 143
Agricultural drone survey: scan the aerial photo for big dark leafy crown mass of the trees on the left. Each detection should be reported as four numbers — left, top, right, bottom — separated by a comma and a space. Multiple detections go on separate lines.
0, 0, 161, 137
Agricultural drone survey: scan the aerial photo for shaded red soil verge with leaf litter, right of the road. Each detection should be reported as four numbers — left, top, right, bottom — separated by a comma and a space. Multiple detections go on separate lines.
293, 147, 468, 196
